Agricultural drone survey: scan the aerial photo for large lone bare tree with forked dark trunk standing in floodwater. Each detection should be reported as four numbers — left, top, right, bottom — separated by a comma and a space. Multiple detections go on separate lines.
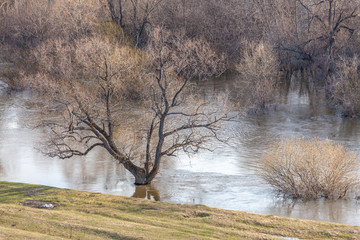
27, 30, 228, 185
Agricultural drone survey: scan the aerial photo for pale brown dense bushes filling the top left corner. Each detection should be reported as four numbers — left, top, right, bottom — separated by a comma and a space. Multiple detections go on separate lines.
1, 0, 102, 49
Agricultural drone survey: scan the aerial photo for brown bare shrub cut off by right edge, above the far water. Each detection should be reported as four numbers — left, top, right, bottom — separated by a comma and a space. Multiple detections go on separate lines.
330, 56, 360, 117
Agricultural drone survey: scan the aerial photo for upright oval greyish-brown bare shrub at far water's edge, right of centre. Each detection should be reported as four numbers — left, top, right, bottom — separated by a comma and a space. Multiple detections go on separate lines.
237, 42, 280, 110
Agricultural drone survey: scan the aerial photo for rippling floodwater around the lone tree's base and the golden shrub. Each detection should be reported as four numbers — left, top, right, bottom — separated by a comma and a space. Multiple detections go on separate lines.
0, 75, 360, 225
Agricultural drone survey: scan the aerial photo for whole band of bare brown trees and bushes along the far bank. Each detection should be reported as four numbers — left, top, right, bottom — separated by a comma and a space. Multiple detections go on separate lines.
0, 0, 360, 116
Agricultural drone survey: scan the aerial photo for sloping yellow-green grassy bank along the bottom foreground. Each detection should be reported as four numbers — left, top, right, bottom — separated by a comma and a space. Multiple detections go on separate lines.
0, 182, 360, 239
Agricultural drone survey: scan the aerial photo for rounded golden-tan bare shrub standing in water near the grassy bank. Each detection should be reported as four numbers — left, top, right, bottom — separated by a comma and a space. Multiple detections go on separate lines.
259, 138, 359, 199
